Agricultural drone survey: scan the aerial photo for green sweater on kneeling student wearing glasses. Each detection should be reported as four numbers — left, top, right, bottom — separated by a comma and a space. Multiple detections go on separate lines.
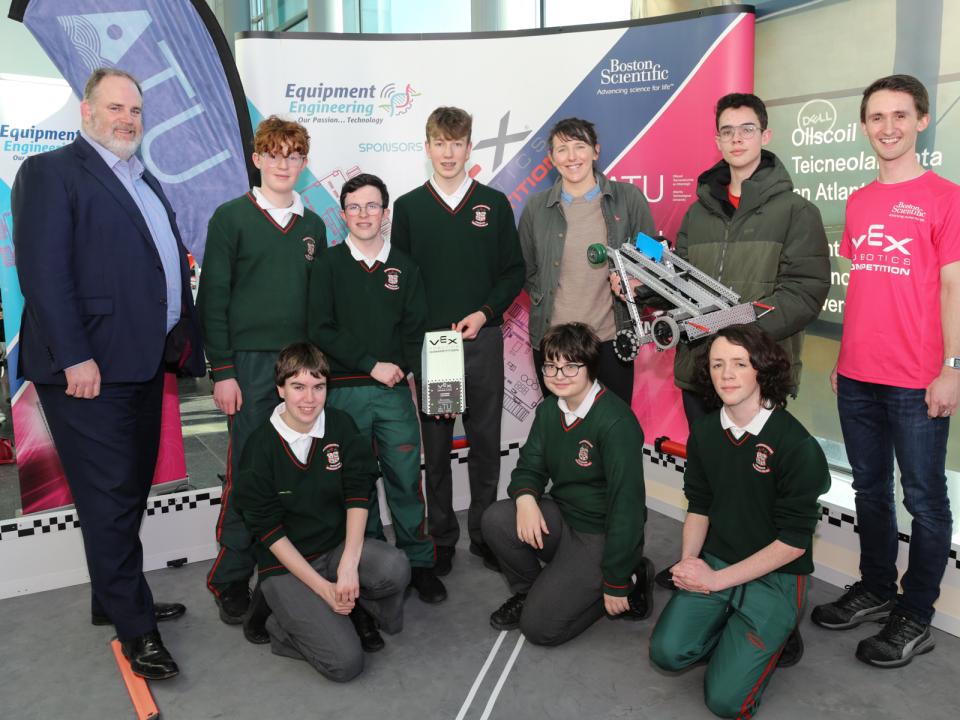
507, 388, 647, 596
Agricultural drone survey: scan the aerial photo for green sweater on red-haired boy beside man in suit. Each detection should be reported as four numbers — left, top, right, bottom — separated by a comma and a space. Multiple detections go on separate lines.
197, 193, 327, 381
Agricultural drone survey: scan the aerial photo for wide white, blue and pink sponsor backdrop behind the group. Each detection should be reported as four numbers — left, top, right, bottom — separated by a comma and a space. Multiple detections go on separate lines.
236, 5, 754, 442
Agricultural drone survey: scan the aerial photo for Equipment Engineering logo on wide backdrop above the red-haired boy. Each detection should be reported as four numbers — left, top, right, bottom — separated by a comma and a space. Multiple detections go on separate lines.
283, 83, 420, 125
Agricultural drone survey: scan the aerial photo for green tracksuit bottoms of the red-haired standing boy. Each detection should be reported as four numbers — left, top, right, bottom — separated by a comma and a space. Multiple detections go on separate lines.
207, 351, 280, 597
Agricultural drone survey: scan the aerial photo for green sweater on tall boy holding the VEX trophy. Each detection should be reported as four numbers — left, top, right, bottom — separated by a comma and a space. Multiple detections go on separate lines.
390, 181, 524, 330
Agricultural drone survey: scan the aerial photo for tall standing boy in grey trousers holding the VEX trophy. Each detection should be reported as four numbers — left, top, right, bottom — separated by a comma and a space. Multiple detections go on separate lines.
390, 107, 524, 575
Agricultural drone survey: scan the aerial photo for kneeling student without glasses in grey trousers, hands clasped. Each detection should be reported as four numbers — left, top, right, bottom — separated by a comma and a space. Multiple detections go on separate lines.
234, 343, 410, 682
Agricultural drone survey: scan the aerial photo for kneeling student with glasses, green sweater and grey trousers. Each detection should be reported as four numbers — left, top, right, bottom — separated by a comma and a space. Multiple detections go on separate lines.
482, 323, 654, 645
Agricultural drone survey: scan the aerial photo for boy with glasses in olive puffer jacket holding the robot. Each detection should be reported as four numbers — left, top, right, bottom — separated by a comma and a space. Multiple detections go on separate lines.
624, 93, 830, 666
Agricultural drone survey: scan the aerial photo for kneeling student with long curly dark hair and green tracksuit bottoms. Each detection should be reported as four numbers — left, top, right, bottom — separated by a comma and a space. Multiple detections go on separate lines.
650, 325, 830, 718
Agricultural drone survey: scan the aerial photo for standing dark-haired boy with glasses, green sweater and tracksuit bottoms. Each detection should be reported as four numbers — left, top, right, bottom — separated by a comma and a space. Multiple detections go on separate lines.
309, 173, 447, 603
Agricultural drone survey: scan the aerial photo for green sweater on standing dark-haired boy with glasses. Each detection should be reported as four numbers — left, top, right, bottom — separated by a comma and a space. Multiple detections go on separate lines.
308, 243, 427, 388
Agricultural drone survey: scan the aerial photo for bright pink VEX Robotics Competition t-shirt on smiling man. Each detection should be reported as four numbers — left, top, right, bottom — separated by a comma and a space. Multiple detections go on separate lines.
837, 171, 960, 388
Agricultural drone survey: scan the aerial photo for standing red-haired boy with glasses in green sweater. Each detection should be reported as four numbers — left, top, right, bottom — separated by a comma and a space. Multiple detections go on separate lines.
197, 115, 327, 642
